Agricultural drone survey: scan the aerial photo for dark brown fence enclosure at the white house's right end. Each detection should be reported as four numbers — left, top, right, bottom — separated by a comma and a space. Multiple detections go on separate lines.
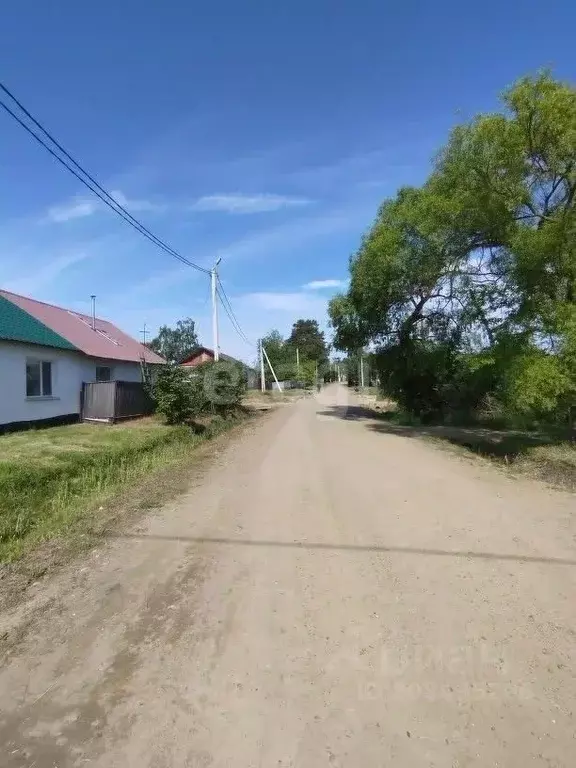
82, 381, 153, 423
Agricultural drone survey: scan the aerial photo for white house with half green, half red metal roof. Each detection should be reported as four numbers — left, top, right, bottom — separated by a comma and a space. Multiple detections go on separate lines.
0, 290, 165, 428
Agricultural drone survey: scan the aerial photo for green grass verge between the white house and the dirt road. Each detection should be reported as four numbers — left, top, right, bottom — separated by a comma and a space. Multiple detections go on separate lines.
0, 418, 243, 562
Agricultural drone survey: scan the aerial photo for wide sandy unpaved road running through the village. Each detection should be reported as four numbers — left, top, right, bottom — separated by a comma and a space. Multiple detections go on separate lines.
0, 385, 576, 768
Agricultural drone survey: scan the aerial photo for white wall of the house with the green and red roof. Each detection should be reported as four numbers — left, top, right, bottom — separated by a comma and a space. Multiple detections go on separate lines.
0, 341, 141, 425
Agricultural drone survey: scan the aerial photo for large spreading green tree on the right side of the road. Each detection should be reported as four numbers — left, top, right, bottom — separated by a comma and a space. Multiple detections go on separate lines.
329, 73, 576, 426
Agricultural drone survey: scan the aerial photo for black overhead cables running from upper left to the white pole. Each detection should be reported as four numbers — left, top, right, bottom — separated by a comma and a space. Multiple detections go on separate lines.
0, 82, 210, 274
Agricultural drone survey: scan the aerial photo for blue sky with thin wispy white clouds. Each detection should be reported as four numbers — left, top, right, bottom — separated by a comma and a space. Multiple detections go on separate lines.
0, 0, 576, 360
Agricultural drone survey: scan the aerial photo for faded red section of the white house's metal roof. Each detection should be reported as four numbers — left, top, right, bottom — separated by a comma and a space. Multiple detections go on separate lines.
0, 290, 166, 363
